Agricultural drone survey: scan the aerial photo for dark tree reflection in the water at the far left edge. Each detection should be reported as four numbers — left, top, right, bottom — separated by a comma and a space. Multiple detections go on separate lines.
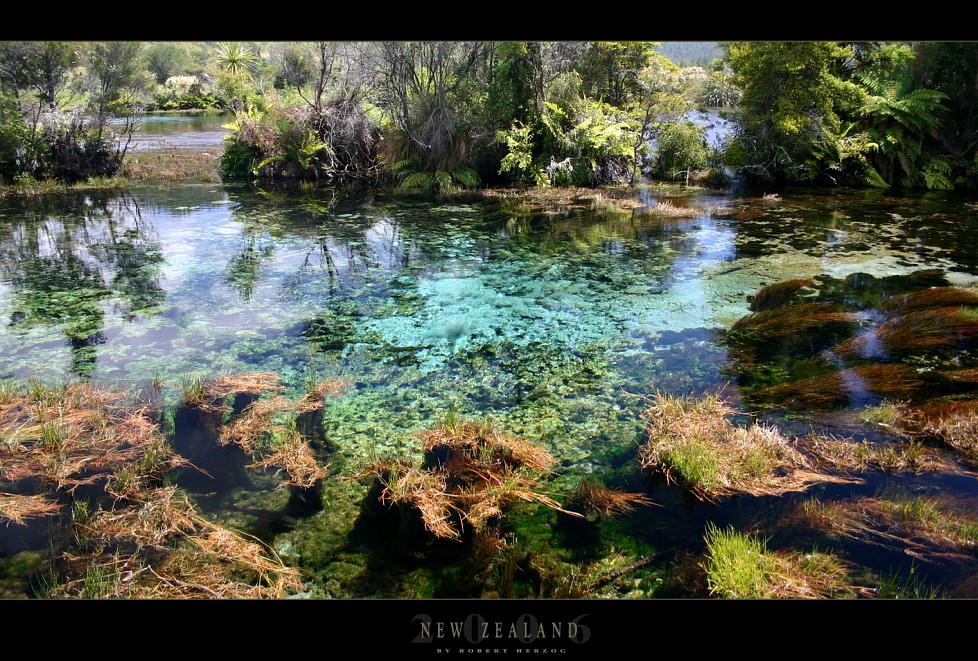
0, 194, 166, 376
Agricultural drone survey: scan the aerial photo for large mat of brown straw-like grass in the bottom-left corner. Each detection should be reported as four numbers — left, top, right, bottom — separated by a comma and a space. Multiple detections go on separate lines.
0, 376, 301, 598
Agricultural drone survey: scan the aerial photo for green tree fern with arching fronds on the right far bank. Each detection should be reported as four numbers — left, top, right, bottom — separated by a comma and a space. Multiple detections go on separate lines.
859, 74, 947, 186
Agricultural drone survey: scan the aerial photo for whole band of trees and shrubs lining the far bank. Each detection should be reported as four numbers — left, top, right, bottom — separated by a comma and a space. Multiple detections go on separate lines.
0, 41, 978, 194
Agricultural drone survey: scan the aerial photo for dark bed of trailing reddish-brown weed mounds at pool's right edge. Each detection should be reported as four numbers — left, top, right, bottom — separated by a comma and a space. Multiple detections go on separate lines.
726, 271, 978, 440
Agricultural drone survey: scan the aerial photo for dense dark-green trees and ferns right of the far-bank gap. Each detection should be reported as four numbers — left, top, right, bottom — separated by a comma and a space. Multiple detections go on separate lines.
726, 42, 978, 189
